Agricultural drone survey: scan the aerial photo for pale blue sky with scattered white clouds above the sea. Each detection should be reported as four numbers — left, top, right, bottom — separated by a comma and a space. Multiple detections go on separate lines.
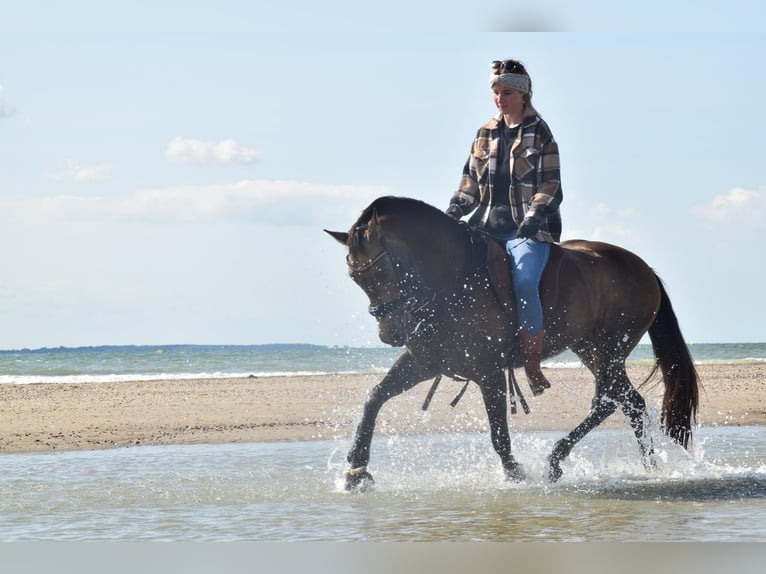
0, 0, 766, 349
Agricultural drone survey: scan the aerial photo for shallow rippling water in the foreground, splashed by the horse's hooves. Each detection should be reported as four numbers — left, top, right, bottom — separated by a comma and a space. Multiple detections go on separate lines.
0, 427, 766, 541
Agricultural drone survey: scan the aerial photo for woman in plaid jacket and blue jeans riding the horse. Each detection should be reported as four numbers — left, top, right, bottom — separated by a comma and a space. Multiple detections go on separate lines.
447, 60, 563, 394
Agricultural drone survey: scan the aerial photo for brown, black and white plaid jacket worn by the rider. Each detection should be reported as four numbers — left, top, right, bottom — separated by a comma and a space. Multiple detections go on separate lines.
450, 106, 563, 242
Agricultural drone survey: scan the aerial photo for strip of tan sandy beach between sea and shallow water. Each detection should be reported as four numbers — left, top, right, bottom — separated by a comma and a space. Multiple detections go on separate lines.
0, 363, 766, 452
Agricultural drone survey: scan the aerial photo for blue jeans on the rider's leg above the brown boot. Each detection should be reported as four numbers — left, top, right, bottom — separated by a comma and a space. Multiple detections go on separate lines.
505, 238, 551, 335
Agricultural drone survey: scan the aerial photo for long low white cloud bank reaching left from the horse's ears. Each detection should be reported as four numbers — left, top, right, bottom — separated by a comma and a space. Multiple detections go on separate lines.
0, 180, 386, 229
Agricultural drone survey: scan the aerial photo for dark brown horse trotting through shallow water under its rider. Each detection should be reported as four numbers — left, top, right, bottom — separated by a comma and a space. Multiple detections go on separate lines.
325, 197, 698, 490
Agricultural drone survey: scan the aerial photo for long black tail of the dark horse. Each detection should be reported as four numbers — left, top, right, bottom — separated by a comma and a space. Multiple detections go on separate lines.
649, 274, 699, 448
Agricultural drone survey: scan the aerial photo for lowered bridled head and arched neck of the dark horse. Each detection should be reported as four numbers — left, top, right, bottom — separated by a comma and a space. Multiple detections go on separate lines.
325, 196, 470, 346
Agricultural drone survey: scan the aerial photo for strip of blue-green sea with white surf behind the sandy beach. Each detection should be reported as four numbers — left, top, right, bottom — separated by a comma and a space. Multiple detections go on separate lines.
0, 343, 766, 384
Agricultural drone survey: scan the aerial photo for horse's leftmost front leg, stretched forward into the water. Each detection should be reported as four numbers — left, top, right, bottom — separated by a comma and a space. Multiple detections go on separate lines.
346, 351, 438, 490
